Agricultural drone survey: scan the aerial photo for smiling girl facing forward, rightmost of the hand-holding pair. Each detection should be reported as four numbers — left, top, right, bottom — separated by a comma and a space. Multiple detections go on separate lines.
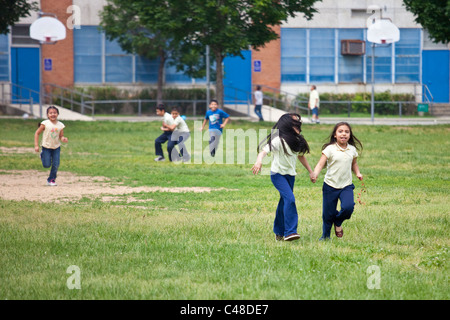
314, 122, 363, 240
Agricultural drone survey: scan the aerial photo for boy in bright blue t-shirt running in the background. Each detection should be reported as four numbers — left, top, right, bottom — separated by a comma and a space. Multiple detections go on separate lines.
201, 100, 230, 157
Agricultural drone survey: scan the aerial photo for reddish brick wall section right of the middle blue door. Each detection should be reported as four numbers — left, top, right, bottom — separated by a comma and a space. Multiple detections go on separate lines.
252, 26, 281, 89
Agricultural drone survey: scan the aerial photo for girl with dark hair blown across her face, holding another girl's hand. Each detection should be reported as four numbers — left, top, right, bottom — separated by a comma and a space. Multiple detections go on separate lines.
252, 113, 316, 241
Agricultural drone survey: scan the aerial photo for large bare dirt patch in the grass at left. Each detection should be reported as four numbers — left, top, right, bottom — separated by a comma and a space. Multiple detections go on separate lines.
0, 170, 229, 203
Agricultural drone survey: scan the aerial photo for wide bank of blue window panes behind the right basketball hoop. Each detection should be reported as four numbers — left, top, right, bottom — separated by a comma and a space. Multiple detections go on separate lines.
281, 28, 422, 83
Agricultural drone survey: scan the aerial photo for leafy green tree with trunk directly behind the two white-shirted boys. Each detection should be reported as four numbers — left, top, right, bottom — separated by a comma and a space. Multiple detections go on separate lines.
100, 0, 204, 103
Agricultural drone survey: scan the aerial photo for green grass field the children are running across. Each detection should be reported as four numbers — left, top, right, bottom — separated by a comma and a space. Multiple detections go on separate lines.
0, 119, 450, 300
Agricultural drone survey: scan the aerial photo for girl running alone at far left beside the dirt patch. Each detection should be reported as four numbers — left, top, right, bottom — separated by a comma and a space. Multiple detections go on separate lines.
34, 106, 69, 186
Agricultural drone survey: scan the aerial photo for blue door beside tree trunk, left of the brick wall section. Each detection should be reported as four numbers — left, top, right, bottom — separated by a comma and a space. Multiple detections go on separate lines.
223, 50, 252, 104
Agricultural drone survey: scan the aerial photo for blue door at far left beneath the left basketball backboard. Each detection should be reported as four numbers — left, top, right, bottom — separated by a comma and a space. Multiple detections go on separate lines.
11, 48, 39, 103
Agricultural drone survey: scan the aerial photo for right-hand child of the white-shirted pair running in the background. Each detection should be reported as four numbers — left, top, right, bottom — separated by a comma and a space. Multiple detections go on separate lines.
165, 108, 191, 162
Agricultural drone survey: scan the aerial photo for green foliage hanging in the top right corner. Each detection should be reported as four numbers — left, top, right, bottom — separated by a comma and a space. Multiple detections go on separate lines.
403, 0, 450, 43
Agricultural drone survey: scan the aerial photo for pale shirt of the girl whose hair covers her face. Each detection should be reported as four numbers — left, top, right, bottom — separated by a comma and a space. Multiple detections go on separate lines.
263, 137, 298, 176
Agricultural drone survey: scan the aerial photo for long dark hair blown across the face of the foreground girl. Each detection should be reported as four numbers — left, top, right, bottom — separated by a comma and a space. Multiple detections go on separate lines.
258, 113, 309, 154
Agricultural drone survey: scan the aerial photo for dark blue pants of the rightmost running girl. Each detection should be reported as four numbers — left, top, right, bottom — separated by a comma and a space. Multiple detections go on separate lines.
322, 183, 355, 238
